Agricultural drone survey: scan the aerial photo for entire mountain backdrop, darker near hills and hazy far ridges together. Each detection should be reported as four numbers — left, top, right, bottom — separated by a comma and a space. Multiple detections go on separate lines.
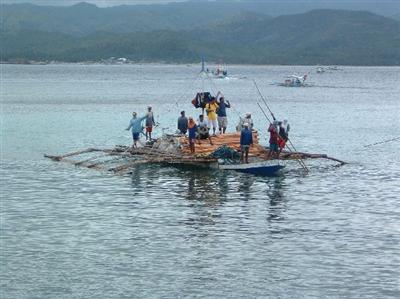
0, 2, 400, 65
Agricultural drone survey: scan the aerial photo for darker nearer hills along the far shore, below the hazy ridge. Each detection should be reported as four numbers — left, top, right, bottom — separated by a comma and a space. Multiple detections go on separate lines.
0, 10, 400, 65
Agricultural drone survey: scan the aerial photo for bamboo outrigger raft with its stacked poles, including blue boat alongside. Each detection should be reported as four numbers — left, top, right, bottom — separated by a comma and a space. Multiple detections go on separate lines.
44, 131, 345, 176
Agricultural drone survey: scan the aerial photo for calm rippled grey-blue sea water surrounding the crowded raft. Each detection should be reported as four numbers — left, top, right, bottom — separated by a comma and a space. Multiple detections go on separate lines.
0, 65, 400, 298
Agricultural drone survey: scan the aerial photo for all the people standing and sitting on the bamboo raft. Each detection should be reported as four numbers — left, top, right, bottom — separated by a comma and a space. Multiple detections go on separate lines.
126, 92, 290, 163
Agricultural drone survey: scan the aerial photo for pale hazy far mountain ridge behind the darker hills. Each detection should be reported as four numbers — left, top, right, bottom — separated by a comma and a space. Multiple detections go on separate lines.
1, 0, 400, 36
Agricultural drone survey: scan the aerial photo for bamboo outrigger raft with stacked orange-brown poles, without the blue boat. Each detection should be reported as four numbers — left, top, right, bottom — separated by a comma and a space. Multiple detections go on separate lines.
44, 131, 345, 174
